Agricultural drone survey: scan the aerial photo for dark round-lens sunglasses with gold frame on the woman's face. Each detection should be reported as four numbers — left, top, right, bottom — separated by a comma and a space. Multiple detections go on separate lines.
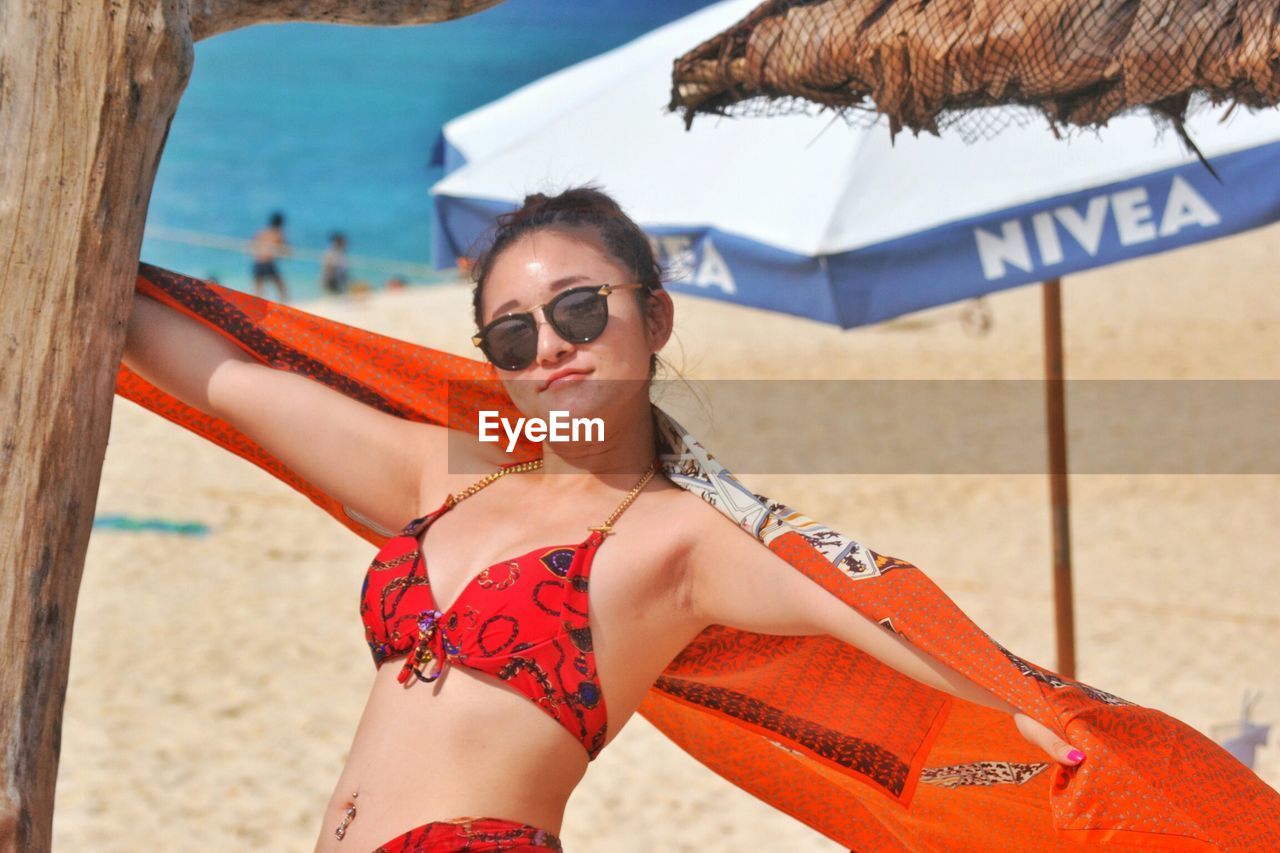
471, 284, 644, 370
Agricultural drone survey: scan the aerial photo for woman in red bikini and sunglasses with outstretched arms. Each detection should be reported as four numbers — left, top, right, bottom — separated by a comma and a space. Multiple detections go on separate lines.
124, 188, 1083, 852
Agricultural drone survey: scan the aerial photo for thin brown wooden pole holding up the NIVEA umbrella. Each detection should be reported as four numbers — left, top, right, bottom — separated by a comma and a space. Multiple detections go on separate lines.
1041, 278, 1075, 679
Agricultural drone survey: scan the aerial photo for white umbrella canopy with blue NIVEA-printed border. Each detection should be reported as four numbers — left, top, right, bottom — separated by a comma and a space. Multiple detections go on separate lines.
431, 0, 1280, 328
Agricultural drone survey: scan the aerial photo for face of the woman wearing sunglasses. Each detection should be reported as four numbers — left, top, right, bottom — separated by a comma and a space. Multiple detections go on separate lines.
480, 227, 671, 425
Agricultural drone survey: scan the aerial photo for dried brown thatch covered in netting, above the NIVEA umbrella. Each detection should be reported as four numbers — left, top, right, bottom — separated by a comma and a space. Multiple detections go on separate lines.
671, 0, 1280, 134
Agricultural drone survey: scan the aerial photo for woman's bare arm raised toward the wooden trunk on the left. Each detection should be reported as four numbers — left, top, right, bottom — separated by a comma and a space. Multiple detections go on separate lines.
124, 293, 481, 532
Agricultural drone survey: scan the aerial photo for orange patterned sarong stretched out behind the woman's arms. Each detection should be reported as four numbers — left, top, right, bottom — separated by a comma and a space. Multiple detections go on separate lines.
118, 264, 1280, 850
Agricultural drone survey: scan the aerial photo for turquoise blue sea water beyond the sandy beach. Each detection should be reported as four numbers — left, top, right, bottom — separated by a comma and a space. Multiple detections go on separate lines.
142, 0, 707, 300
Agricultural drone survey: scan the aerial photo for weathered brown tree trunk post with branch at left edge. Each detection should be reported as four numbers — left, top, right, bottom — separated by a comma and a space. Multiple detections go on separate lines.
0, 0, 499, 853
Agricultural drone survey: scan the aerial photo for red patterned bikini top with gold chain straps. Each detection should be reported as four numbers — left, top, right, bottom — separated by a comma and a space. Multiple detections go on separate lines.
360, 460, 655, 758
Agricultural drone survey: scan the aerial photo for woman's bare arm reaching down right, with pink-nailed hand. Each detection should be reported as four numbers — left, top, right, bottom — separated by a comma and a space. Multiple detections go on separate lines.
682, 507, 1084, 766
